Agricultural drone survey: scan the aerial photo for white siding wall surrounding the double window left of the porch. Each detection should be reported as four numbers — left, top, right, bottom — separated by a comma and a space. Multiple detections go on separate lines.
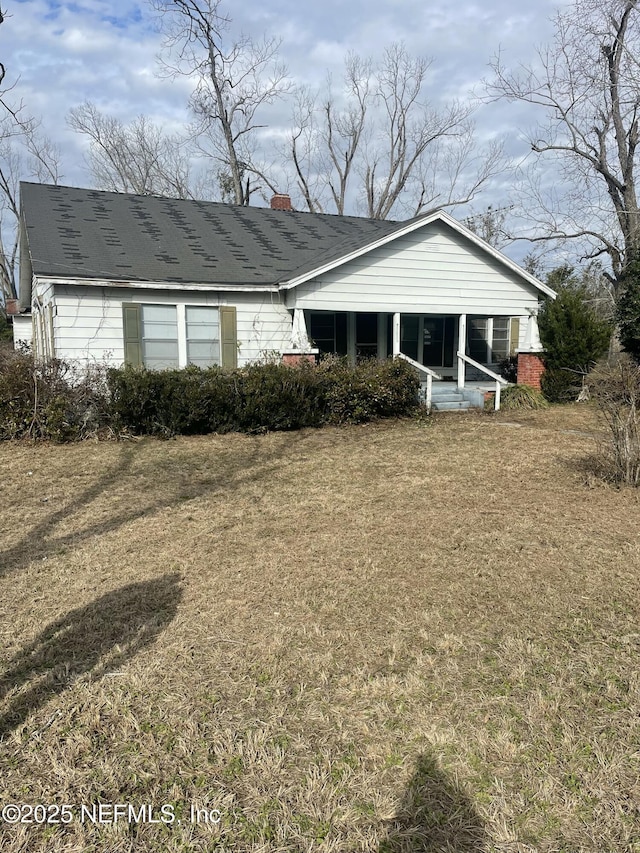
47, 284, 291, 365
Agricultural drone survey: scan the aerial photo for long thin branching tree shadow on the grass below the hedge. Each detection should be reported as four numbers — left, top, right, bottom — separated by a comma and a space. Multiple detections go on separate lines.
0, 434, 304, 577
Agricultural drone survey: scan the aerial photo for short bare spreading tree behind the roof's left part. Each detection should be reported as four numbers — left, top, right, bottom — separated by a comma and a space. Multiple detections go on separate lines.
67, 101, 198, 198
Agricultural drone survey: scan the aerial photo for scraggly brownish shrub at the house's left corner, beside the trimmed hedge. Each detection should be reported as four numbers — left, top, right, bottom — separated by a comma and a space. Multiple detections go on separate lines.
0, 347, 109, 442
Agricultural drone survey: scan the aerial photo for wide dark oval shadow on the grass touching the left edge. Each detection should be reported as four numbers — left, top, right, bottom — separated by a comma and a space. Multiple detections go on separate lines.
0, 574, 182, 739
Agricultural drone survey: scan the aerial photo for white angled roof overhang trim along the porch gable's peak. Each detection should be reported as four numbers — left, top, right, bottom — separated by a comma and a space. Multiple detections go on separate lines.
280, 210, 557, 299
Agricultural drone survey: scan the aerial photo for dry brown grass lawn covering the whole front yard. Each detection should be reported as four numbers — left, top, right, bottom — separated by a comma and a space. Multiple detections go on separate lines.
0, 407, 640, 853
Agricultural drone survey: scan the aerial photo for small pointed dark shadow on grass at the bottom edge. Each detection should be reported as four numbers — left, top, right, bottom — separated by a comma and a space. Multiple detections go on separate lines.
378, 756, 487, 853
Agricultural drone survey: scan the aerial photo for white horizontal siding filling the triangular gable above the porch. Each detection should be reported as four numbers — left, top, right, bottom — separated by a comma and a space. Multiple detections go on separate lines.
288, 222, 538, 316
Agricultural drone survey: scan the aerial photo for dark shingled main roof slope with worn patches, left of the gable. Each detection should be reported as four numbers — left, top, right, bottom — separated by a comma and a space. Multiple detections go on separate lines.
20, 183, 404, 287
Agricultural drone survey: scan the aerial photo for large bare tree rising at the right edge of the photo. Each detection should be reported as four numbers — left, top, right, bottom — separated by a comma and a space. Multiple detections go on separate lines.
488, 0, 640, 285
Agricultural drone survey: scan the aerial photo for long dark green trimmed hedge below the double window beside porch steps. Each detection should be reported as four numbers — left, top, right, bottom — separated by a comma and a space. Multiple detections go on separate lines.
108, 359, 419, 436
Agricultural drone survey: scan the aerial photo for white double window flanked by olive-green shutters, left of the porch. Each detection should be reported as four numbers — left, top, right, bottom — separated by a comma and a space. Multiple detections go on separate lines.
122, 303, 238, 370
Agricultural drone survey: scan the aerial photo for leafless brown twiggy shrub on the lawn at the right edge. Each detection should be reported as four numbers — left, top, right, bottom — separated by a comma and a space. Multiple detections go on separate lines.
589, 354, 640, 486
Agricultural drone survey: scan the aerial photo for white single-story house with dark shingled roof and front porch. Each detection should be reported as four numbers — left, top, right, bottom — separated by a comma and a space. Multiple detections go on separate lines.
14, 183, 555, 408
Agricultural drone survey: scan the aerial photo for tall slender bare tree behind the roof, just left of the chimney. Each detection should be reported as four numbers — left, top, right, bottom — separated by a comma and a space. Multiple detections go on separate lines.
152, 0, 289, 205
